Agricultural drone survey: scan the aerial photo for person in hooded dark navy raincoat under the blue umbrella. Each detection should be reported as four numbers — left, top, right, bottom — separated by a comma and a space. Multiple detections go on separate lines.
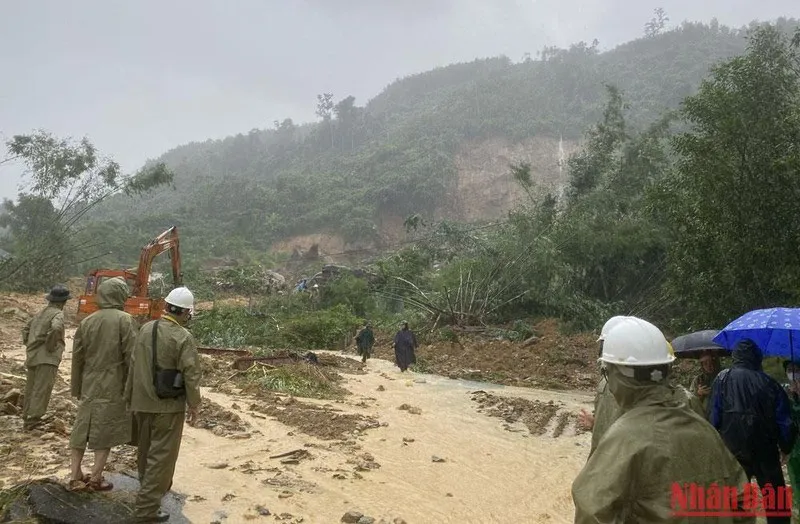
709, 339, 797, 524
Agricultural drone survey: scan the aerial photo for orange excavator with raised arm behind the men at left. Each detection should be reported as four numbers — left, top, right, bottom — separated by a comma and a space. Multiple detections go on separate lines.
77, 226, 183, 322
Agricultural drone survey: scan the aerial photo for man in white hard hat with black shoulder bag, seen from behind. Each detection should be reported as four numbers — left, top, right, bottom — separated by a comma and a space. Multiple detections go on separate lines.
125, 287, 201, 522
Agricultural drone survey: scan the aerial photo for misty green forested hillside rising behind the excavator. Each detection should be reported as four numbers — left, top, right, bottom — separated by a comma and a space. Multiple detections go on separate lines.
88, 20, 792, 263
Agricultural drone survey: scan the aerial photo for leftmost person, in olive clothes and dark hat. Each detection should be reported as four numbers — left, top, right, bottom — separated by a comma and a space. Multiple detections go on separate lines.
22, 284, 70, 430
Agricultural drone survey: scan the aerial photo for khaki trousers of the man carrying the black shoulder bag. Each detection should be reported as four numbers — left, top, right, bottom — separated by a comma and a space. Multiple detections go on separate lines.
134, 412, 186, 519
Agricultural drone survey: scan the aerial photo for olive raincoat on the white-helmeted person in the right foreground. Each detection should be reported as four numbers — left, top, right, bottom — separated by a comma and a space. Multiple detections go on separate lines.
572, 366, 755, 524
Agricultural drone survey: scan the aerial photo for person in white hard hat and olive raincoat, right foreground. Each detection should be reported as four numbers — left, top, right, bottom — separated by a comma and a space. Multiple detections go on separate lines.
572, 317, 755, 524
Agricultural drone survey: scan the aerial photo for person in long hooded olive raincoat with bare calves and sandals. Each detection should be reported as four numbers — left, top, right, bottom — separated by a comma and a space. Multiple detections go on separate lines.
69, 277, 139, 491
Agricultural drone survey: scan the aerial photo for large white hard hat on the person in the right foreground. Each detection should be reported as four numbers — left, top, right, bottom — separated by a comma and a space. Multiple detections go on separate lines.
600, 317, 675, 366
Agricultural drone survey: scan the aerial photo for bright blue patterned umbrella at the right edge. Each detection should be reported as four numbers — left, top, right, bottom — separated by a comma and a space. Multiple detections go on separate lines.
714, 307, 800, 360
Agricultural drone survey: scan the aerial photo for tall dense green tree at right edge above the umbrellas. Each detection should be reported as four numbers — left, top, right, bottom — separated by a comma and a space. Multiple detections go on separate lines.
654, 26, 800, 327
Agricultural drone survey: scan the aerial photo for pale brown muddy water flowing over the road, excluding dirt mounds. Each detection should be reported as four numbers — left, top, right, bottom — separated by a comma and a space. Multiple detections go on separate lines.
6, 334, 592, 524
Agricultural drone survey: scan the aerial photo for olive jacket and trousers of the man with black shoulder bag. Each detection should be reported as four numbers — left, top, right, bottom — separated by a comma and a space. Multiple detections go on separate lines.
125, 315, 200, 520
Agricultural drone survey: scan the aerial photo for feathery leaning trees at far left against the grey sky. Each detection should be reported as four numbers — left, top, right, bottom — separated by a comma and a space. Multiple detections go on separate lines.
0, 131, 173, 289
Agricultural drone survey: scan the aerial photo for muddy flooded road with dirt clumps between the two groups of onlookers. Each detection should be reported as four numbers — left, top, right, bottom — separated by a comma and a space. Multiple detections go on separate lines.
2, 318, 592, 524
